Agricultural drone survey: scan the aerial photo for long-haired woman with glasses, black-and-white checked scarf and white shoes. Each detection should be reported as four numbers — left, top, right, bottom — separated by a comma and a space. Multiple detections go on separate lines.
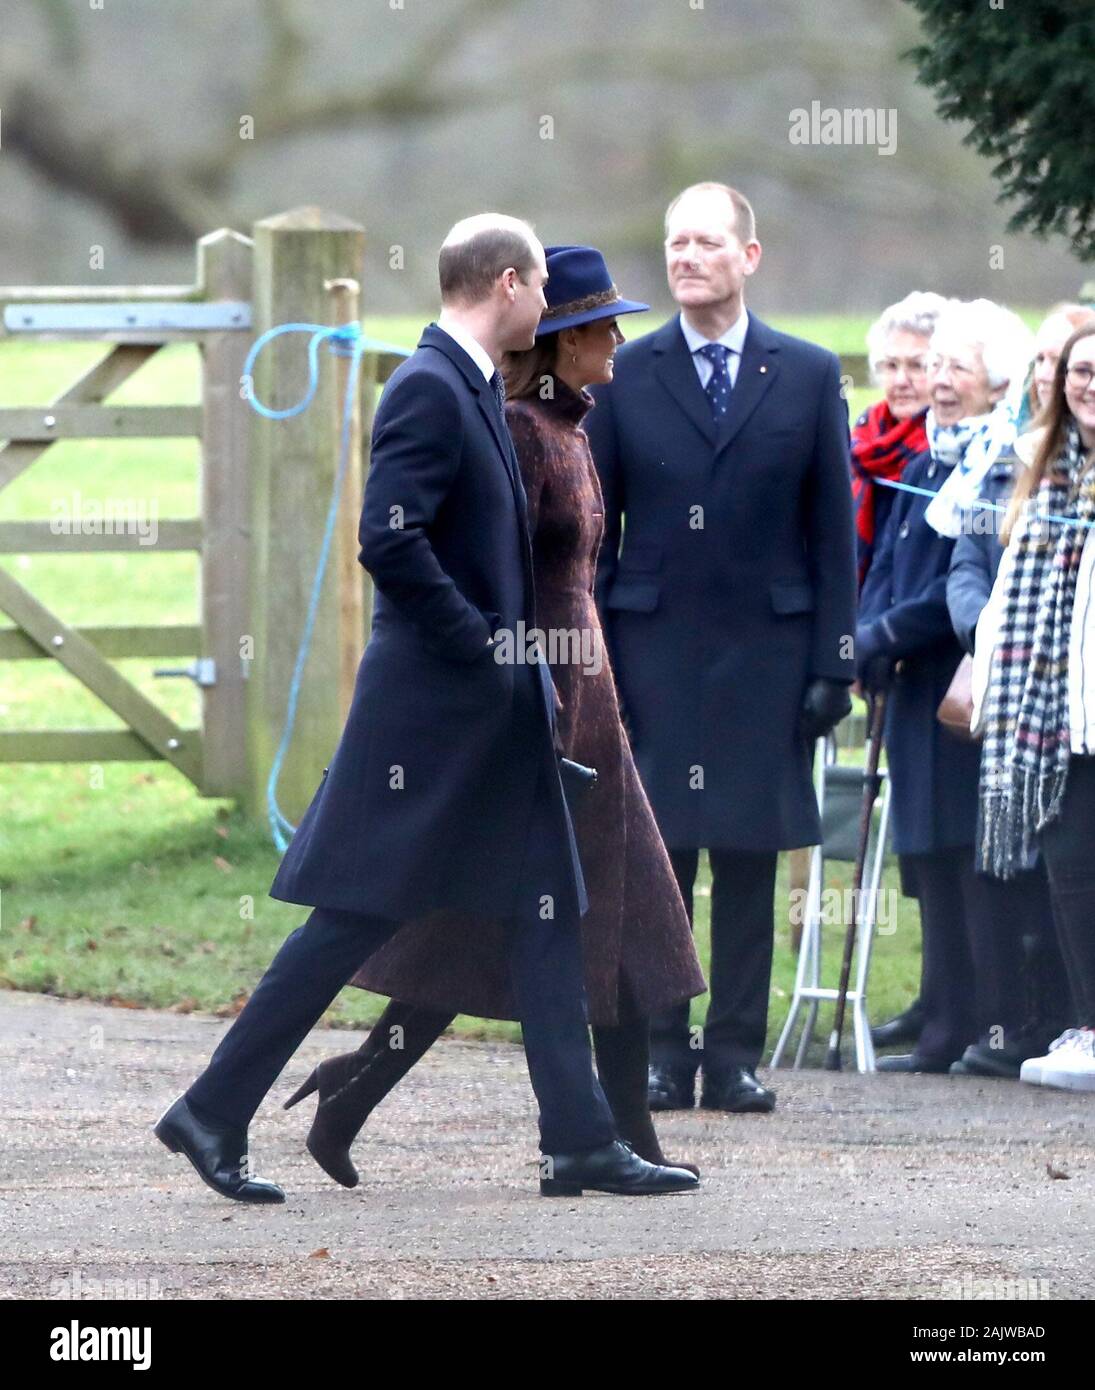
974, 322, 1095, 1091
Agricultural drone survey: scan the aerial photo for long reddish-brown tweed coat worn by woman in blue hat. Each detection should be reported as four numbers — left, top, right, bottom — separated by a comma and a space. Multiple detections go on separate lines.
353, 378, 706, 1024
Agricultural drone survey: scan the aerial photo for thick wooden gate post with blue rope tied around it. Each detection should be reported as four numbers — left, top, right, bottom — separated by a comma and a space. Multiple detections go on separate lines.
245, 207, 365, 824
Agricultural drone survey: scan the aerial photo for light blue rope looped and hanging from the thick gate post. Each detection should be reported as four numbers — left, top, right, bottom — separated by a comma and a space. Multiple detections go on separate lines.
242, 324, 410, 853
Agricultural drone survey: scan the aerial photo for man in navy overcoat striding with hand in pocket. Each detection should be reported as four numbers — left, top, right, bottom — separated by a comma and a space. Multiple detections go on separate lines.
156, 214, 696, 1202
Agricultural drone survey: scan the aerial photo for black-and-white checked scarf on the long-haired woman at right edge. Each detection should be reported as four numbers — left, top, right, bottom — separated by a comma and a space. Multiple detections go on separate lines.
978, 421, 1095, 878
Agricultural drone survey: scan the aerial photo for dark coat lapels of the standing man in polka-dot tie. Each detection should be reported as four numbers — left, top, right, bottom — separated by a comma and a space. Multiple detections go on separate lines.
652, 313, 780, 453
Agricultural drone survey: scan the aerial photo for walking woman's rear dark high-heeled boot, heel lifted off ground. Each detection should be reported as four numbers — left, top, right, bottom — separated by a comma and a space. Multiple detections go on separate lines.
285, 999, 456, 1187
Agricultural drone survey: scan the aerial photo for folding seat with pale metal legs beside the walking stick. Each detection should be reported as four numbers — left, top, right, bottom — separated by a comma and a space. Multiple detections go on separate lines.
771, 734, 891, 1072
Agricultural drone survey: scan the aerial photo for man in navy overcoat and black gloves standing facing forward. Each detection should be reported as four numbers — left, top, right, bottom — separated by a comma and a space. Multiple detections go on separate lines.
586, 183, 856, 1111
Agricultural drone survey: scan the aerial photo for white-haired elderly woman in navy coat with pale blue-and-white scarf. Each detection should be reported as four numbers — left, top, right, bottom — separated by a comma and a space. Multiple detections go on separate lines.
856, 299, 1031, 1072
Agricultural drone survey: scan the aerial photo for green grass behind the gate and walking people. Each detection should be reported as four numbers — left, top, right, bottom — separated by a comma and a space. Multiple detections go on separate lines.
0, 316, 920, 1037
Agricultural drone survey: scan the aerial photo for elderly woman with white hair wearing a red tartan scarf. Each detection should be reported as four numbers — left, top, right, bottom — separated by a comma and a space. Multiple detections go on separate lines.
852, 289, 946, 587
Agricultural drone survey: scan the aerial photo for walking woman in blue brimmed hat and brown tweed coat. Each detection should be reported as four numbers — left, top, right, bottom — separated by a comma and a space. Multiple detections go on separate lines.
286, 246, 706, 1187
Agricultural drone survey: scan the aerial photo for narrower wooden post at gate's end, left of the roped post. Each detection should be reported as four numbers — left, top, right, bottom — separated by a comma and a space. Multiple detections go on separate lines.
197, 228, 252, 796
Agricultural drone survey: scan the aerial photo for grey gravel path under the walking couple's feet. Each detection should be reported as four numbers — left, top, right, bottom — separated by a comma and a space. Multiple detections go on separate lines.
0, 991, 1095, 1298
